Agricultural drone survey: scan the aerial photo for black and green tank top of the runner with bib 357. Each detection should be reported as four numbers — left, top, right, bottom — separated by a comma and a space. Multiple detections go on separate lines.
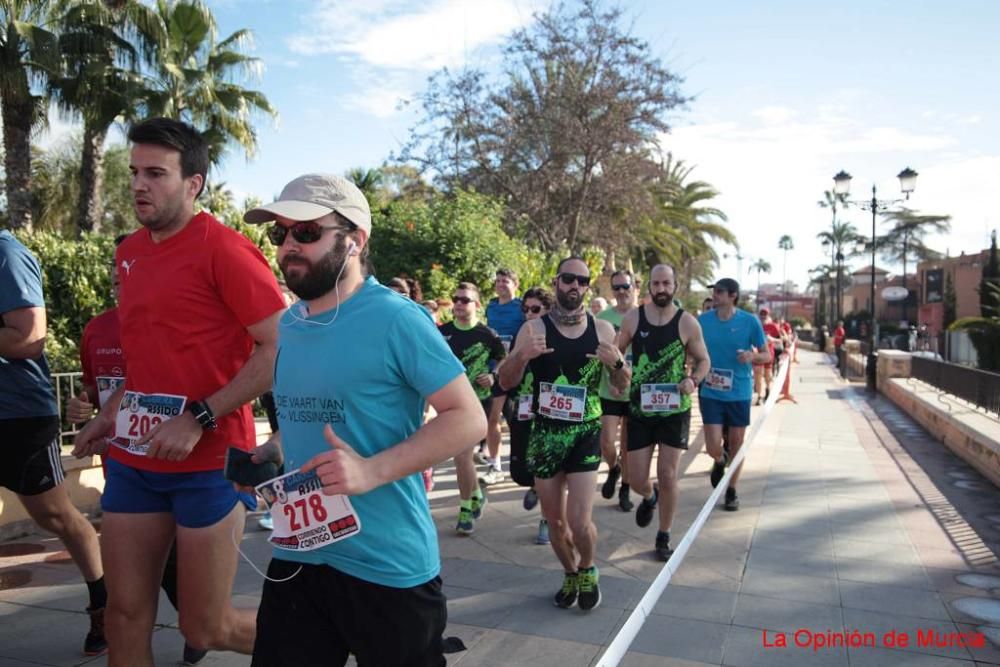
629, 307, 691, 417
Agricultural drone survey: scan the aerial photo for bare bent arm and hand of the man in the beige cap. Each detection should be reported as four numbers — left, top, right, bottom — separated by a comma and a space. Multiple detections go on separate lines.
302, 374, 486, 495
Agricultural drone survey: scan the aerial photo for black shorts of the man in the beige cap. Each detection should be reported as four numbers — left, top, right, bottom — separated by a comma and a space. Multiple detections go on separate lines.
251, 554, 448, 667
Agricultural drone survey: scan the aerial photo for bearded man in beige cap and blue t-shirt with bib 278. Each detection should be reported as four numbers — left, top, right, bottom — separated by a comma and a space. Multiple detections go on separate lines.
238, 174, 486, 667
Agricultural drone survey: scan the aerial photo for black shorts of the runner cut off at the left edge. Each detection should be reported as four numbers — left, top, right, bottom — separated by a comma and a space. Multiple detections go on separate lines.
0, 416, 66, 496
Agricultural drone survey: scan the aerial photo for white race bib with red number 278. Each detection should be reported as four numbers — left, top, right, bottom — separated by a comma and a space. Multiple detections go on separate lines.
257, 470, 361, 551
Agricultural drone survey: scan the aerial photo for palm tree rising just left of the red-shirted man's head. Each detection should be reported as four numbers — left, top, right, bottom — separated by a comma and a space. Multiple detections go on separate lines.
50, 0, 163, 233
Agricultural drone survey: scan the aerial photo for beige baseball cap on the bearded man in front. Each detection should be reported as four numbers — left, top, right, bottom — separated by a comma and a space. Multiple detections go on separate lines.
243, 174, 372, 235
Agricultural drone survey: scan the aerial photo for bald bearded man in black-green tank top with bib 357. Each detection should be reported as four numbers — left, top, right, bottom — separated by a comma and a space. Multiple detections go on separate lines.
618, 264, 710, 561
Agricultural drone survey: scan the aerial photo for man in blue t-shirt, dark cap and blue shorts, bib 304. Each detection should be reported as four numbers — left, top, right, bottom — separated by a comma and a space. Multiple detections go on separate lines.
698, 278, 770, 512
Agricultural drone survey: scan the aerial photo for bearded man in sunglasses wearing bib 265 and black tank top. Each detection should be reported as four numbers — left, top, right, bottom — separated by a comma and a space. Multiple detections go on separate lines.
500, 257, 631, 611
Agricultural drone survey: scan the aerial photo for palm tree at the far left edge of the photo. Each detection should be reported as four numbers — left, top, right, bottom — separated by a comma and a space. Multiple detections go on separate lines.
0, 0, 59, 229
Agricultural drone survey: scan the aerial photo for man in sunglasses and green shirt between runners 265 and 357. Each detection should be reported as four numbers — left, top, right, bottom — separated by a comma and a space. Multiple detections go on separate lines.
597, 269, 637, 512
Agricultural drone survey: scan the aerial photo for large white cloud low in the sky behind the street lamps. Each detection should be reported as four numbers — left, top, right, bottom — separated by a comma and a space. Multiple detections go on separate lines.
661, 106, 988, 285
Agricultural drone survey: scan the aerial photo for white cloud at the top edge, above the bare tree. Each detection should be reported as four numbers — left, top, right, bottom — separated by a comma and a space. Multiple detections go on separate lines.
288, 0, 538, 70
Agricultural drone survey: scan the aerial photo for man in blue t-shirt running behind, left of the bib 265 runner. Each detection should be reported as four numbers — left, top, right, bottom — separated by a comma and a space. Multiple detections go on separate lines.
477, 268, 524, 484
